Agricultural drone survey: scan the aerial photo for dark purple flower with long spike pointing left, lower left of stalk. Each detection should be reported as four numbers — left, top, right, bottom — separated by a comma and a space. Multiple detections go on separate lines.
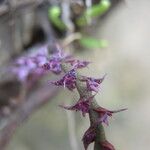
60, 95, 95, 117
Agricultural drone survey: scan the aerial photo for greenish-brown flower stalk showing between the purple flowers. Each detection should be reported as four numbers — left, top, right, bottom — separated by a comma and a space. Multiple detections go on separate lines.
62, 63, 114, 150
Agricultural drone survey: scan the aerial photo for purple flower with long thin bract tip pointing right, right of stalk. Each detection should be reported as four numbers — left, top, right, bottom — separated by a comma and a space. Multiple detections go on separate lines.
94, 107, 127, 125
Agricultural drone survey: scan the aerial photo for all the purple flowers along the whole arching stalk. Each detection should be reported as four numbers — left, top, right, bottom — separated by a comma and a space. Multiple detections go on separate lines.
12, 46, 126, 150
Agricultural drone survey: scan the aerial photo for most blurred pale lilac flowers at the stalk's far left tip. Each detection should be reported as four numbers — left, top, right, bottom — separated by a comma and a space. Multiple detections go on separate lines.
11, 46, 48, 82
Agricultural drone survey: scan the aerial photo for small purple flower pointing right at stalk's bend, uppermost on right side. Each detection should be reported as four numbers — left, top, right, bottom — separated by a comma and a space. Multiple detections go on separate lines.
66, 59, 90, 69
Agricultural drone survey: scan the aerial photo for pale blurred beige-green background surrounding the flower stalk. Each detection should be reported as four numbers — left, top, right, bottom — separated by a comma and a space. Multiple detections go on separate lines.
0, 0, 150, 150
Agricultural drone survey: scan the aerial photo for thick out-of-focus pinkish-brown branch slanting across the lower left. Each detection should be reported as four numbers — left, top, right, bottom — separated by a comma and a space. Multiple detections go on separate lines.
0, 86, 58, 150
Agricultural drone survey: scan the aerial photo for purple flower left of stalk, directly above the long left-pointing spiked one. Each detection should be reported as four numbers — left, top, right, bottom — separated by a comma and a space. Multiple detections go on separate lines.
51, 69, 77, 91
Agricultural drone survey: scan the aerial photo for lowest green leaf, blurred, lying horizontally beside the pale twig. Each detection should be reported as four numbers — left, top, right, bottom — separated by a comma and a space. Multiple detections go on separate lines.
79, 37, 108, 48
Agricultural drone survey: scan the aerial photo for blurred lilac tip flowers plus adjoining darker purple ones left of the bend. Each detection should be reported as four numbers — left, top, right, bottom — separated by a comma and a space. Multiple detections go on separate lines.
11, 45, 70, 82
